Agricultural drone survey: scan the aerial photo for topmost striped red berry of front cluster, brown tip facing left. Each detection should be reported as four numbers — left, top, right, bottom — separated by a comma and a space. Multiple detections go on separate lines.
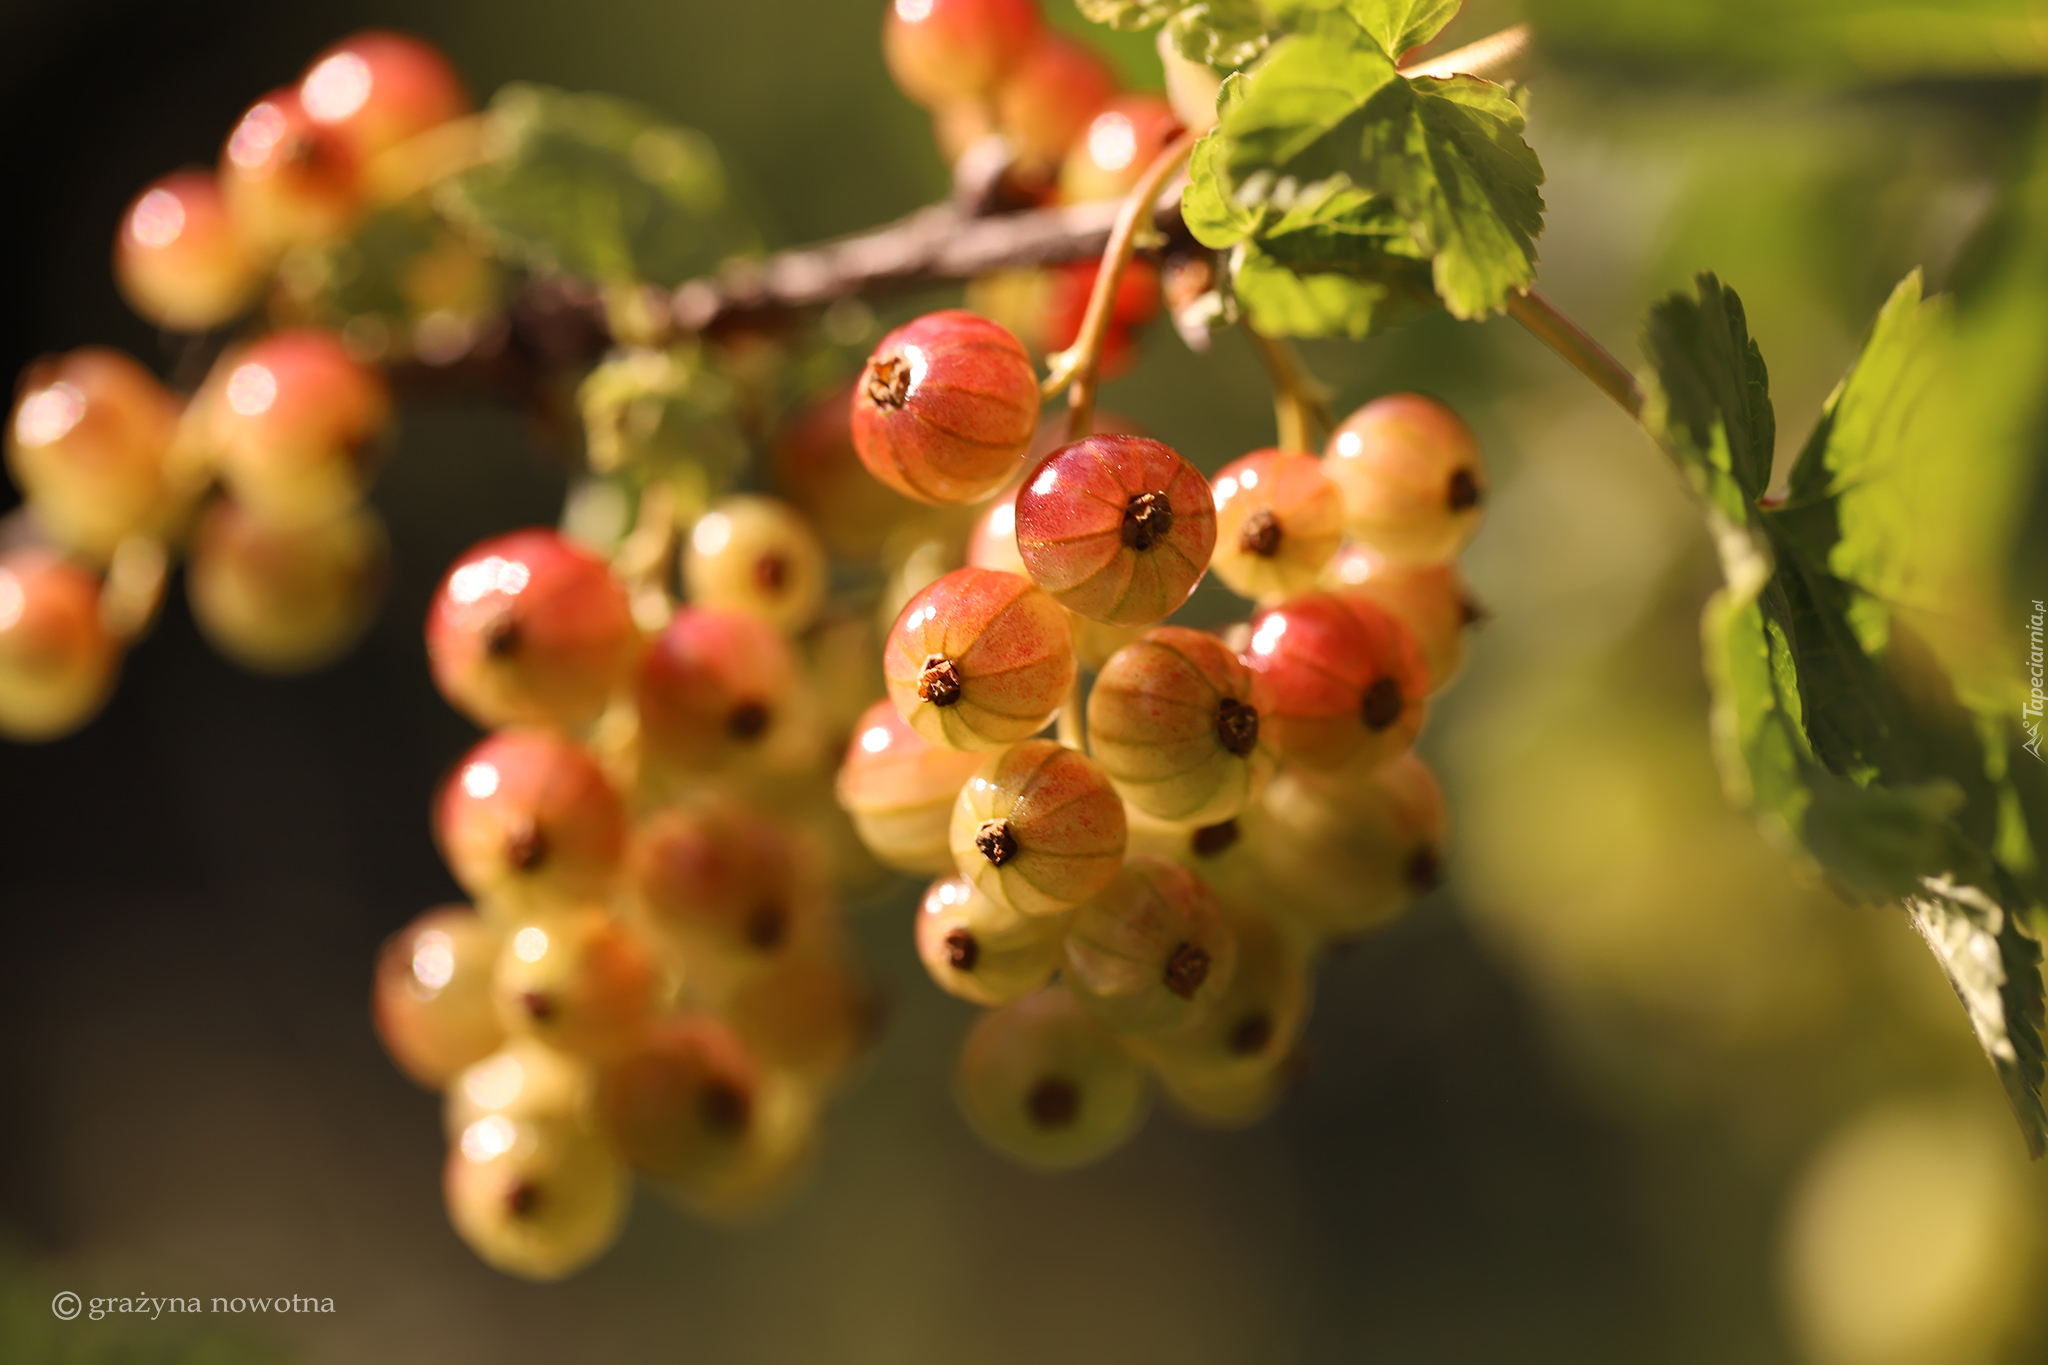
852, 309, 1038, 503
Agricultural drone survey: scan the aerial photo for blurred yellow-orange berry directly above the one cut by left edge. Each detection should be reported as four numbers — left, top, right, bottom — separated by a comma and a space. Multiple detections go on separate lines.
6, 346, 178, 561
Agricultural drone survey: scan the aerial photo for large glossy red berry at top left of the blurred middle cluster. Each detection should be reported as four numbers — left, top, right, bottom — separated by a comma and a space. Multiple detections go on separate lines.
426, 526, 641, 729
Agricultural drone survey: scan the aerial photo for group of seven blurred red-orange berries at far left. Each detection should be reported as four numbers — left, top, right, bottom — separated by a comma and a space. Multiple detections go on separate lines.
0, 33, 469, 739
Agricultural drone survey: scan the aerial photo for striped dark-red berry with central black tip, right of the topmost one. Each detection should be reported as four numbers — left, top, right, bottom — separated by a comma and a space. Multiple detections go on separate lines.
1016, 436, 1217, 626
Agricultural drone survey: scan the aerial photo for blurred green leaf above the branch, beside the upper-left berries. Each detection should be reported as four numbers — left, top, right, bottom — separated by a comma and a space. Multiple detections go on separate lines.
436, 86, 752, 284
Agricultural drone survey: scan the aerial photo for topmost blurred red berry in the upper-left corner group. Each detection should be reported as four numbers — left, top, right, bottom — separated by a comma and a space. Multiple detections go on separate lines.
299, 29, 469, 166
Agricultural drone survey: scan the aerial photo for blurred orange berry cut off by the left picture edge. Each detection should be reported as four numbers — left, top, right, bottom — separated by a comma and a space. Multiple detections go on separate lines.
0, 548, 121, 740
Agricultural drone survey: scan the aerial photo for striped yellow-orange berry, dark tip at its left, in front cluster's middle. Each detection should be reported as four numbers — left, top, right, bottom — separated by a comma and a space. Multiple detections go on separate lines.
952, 739, 1128, 915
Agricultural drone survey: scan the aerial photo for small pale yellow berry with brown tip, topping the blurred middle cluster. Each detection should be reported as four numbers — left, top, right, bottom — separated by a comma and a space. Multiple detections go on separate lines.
682, 497, 827, 634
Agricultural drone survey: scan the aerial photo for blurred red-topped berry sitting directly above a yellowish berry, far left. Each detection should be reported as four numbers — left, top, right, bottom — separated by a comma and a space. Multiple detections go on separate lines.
211, 327, 391, 522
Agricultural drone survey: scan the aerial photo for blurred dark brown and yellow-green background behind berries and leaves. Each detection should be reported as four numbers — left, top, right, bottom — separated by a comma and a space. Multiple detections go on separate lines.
12, 0, 2048, 1365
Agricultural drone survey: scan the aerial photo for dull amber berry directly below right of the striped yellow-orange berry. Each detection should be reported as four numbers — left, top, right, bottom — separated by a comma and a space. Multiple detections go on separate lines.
1063, 857, 1237, 1036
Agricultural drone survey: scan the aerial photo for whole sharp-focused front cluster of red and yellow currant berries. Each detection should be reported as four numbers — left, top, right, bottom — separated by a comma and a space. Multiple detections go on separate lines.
840, 311, 1485, 1166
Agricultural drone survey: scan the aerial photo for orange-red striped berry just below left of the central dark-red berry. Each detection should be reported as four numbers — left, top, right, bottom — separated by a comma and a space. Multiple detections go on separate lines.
883, 569, 1075, 749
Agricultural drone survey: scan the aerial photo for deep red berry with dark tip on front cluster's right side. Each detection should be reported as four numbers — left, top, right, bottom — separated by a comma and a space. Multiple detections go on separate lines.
1243, 591, 1430, 769
